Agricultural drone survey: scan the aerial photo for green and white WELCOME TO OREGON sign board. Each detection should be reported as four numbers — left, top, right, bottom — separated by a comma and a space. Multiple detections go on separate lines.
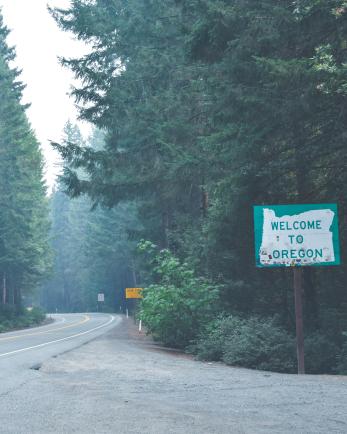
254, 204, 340, 267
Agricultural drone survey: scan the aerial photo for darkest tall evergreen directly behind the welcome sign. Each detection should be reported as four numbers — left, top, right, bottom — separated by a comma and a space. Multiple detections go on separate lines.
186, 0, 347, 327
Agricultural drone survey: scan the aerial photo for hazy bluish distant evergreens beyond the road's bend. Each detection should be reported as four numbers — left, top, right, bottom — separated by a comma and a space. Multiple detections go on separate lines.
42, 123, 141, 311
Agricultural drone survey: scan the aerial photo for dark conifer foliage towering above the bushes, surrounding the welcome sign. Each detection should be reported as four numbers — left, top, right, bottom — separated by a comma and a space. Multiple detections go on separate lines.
52, 0, 347, 371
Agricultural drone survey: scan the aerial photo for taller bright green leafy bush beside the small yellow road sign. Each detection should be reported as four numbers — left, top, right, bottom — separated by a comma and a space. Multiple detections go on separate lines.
140, 242, 219, 348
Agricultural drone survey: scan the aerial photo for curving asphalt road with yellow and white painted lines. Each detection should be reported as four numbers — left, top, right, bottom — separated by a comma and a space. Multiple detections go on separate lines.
0, 313, 120, 424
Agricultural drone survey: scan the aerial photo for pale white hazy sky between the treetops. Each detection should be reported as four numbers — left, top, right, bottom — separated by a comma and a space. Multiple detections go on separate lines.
0, 0, 90, 186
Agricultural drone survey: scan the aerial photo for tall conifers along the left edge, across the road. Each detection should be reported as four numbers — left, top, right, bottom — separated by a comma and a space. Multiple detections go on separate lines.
0, 14, 51, 310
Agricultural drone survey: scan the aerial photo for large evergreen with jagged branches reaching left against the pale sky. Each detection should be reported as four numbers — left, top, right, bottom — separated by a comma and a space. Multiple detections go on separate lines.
50, 1, 209, 248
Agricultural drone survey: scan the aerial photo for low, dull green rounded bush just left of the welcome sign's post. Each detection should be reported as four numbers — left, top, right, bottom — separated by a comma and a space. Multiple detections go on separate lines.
195, 316, 296, 372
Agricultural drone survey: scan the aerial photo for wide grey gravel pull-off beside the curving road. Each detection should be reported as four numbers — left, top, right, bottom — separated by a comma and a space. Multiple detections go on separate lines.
1, 319, 347, 434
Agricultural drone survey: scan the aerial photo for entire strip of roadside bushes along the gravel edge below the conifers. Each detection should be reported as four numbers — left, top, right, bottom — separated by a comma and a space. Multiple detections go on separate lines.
138, 241, 347, 374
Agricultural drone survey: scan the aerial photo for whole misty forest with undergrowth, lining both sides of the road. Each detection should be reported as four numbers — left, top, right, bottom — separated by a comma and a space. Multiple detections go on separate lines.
0, 0, 347, 374
